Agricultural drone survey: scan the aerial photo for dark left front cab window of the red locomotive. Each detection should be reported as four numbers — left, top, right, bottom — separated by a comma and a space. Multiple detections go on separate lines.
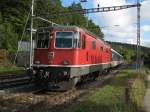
36, 32, 50, 48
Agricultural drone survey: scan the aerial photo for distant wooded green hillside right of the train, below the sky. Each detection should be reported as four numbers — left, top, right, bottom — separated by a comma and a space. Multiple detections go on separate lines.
109, 42, 150, 68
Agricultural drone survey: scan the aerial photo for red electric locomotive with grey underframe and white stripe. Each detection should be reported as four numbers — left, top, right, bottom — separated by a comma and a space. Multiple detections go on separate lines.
32, 26, 111, 88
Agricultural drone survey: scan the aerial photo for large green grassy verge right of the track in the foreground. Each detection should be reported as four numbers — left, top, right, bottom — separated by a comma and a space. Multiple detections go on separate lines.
68, 69, 145, 112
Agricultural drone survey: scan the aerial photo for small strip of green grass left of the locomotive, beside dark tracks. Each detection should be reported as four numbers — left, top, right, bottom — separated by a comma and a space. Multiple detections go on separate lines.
0, 66, 24, 74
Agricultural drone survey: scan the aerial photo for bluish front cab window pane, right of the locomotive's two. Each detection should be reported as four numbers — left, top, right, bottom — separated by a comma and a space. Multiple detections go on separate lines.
55, 32, 74, 48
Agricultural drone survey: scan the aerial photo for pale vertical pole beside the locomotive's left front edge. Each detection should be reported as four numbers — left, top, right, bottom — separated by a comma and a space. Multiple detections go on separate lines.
30, 0, 34, 69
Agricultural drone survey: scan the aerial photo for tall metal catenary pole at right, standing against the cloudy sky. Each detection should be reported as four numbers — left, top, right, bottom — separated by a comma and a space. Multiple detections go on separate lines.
136, 0, 141, 73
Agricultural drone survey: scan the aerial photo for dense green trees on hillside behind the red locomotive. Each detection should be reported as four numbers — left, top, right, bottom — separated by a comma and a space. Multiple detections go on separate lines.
0, 0, 103, 55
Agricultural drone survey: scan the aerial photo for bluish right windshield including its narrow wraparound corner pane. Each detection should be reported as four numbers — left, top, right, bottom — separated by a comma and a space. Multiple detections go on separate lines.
55, 32, 79, 48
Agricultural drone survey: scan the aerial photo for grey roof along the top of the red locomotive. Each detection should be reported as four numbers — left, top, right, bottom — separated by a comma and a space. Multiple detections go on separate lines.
37, 26, 110, 46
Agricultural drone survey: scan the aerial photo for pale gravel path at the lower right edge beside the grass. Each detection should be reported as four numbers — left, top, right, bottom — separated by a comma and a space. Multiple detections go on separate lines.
144, 74, 150, 112
